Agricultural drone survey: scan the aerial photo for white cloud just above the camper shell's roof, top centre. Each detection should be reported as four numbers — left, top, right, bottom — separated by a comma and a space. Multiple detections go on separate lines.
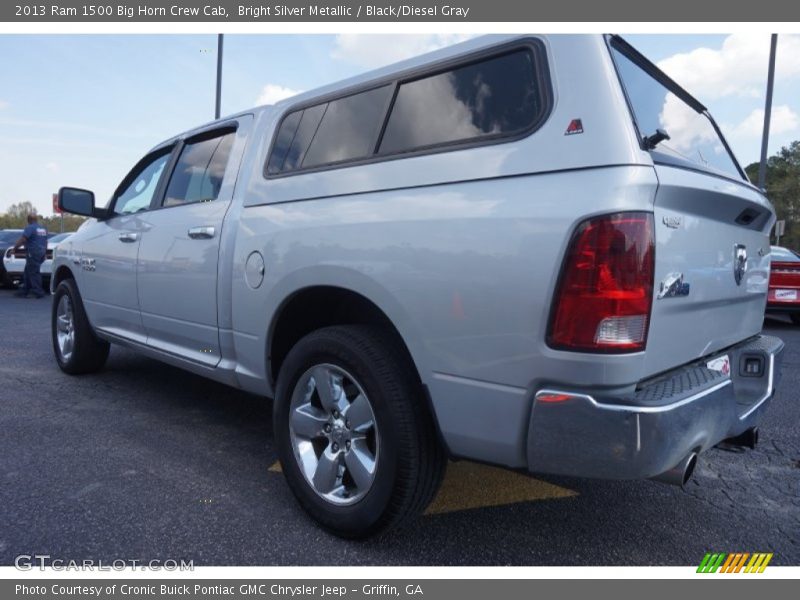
333, 33, 473, 69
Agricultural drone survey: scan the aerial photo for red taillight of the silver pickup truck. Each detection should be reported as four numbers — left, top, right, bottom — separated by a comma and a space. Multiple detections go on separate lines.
547, 212, 655, 353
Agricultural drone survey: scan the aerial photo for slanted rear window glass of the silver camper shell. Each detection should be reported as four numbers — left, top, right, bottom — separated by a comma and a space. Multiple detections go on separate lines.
611, 45, 742, 179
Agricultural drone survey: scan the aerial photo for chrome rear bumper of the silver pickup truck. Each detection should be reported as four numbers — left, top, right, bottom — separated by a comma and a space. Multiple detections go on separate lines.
527, 336, 784, 479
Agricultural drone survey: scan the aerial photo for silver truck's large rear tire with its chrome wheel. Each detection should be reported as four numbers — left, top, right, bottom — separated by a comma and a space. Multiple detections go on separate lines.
274, 325, 446, 538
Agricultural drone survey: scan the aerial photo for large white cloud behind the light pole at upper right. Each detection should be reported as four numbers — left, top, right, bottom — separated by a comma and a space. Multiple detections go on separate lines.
658, 33, 800, 101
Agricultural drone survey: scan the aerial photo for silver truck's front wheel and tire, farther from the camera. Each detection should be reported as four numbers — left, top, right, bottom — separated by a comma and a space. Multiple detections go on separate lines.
51, 279, 109, 375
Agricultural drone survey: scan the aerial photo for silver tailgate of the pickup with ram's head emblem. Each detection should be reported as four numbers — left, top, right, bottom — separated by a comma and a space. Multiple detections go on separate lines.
644, 164, 774, 376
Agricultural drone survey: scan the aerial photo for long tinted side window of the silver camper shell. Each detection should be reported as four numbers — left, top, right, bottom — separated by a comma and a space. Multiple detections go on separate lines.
264, 39, 552, 177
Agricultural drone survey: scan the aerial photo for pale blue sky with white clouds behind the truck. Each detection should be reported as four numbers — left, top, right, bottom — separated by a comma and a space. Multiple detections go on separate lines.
0, 34, 800, 215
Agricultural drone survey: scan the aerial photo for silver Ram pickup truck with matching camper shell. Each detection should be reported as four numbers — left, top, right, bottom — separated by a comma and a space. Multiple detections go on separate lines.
52, 35, 783, 537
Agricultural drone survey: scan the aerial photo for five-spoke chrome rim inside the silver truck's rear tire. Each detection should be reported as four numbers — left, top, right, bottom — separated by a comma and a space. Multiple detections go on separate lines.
289, 364, 378, 506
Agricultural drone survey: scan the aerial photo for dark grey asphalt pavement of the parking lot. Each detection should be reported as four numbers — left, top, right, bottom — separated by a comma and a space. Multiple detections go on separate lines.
0, 290, 800, 566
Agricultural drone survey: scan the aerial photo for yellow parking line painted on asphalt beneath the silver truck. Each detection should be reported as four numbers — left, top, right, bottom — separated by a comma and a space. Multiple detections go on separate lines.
268, 460, 578, 515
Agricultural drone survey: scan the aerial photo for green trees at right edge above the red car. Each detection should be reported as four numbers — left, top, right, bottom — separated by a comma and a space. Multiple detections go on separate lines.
745, 140, 800, 250
